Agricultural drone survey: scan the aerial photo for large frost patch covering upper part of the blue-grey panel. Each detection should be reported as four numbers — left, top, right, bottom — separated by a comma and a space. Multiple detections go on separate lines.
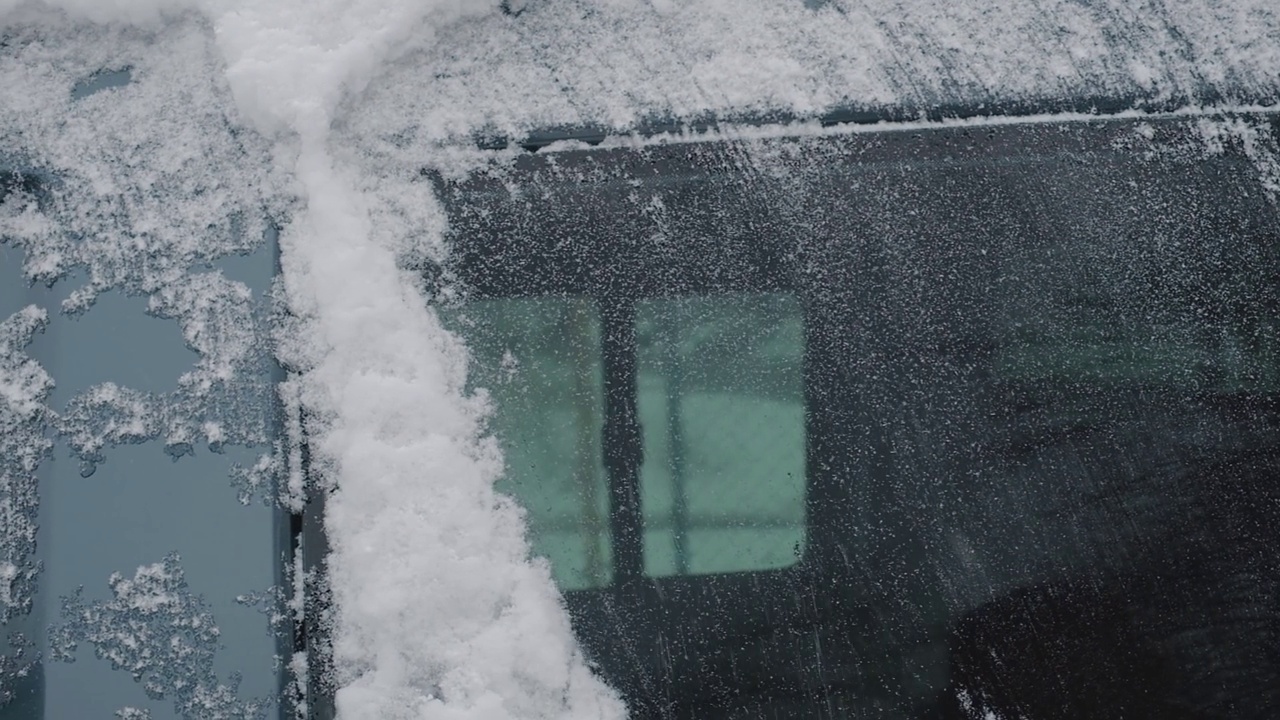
0, 5, 291, 471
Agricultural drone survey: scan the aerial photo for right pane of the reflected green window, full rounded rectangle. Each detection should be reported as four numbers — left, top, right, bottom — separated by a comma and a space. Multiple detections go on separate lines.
636, 288, 805, 575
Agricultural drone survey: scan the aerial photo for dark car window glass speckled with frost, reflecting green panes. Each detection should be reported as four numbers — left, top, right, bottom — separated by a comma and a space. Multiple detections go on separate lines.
440, 114, 1280, 719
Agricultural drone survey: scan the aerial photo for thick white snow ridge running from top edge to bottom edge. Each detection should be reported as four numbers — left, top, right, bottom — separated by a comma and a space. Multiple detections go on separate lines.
200, 0, 623, 720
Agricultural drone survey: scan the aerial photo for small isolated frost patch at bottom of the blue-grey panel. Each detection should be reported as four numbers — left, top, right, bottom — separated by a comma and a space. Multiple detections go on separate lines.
50, 553, 270, 720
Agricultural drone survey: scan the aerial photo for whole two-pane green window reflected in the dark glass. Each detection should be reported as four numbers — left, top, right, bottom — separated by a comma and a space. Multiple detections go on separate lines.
445, 293, 805, 591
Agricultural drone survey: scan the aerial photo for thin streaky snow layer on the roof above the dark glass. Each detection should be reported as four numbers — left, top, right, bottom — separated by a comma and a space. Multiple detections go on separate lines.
344, 0, 1280, 143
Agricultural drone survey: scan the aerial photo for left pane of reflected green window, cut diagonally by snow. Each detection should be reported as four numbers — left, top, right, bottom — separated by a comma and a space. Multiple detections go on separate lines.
445, 299, 613, 589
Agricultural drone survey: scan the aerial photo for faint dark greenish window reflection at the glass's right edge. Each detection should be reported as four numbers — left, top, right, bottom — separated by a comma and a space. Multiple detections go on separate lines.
993, 240, 1280, 393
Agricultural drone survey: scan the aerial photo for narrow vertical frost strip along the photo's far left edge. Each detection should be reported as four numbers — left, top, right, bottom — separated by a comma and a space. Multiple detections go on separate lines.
0, 305, 54, 707
